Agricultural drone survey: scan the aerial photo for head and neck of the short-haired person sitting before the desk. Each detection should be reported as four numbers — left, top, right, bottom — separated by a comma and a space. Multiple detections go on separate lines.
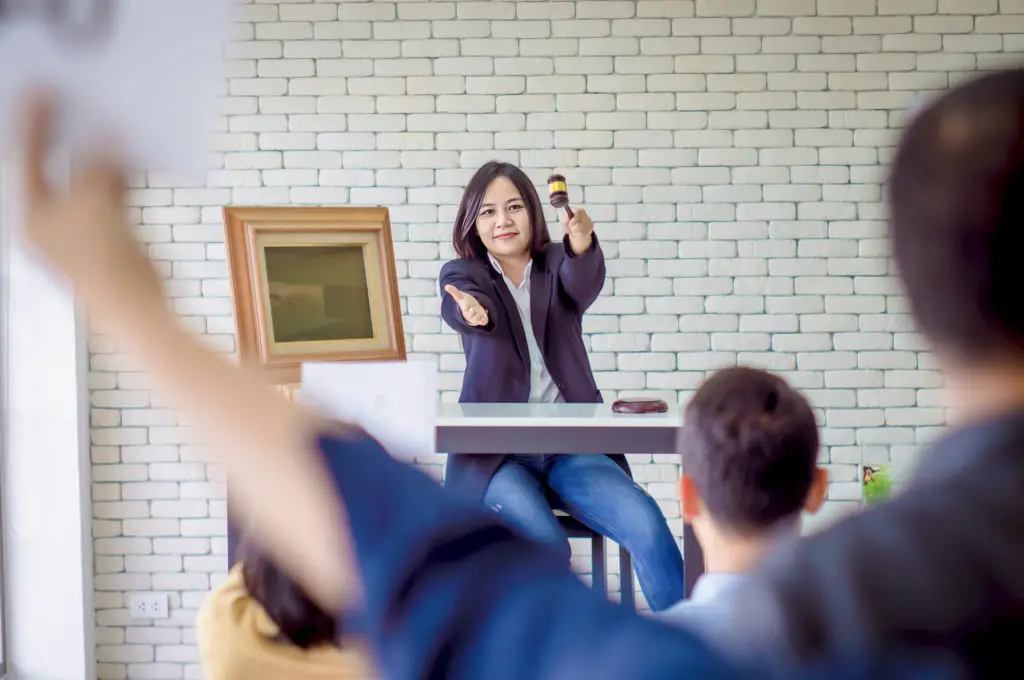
679, 367, 828, 571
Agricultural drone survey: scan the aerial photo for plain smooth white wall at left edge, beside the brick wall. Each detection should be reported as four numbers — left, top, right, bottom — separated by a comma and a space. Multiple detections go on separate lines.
0, 161, 96, 680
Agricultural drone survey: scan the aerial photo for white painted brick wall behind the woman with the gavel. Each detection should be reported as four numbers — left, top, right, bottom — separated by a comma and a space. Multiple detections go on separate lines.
90, 0, 1024, 680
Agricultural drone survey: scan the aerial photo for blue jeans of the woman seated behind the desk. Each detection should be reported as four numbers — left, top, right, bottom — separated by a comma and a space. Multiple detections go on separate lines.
483, 454, 683, 611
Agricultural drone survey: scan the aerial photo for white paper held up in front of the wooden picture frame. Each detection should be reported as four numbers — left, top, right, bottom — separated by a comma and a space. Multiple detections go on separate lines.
298, 360, 437, 463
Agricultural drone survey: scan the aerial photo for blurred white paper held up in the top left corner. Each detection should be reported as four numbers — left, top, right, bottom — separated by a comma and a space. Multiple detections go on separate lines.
0, 0, 232, 171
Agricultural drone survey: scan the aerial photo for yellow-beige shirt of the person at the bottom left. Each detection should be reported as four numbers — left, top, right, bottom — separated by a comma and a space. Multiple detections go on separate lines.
196, 565, 377, 680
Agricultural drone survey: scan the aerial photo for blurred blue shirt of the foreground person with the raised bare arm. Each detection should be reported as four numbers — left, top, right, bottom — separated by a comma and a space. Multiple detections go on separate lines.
318, 434, 954, 680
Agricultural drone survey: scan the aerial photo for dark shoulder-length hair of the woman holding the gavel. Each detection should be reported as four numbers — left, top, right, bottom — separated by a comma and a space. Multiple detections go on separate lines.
452, 161, 551, 260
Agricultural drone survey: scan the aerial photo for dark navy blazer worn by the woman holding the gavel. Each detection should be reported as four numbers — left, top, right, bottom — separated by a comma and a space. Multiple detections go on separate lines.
440, 235, 630, 499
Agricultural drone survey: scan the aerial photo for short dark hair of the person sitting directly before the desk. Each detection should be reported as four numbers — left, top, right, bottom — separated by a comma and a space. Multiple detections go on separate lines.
679, 367, 818, 535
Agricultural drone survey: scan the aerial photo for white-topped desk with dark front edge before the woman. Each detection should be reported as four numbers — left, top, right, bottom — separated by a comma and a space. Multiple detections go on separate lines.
436, 403, 703, 597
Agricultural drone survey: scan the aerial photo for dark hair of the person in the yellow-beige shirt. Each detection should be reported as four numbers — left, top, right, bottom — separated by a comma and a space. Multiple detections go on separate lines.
239, 539, 340, 649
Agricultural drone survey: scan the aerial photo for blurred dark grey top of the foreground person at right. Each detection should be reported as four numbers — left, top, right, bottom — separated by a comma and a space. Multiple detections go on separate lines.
721, 407, 1024, 678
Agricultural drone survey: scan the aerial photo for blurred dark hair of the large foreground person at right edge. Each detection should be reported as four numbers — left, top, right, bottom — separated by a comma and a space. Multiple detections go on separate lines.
889, 70, 1024, 363
